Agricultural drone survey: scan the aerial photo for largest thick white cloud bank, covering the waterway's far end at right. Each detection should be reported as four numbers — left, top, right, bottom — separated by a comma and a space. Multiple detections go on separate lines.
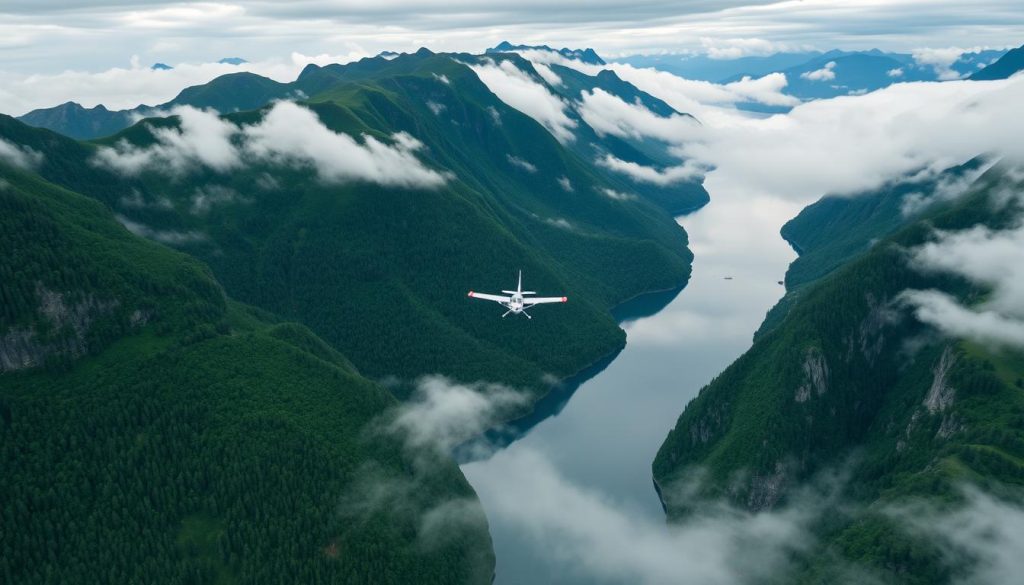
655, 79, 1024, 205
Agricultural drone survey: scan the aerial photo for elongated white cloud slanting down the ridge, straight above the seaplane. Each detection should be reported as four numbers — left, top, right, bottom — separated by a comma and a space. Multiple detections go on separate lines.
469, 58, 577, 143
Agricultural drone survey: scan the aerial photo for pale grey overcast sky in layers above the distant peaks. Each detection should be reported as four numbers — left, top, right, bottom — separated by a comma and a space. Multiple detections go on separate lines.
6, 0, 1024, 74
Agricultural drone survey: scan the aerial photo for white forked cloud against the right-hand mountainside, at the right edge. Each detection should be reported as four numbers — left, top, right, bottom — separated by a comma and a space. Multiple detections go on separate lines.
900, 211, 1024, 347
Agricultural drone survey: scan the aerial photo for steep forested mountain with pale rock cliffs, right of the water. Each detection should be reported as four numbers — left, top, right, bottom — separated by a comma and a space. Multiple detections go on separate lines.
653, 166, 1024, 584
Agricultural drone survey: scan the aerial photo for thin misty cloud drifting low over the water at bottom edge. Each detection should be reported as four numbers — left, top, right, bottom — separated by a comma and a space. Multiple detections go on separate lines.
463, 444, 831, 585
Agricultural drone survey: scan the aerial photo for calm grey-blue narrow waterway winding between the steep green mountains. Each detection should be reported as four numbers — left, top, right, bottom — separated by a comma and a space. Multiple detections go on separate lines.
463, 178, 799, 585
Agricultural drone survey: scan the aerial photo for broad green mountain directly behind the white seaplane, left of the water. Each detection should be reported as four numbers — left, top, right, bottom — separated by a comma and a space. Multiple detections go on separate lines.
0, 50, 706, 409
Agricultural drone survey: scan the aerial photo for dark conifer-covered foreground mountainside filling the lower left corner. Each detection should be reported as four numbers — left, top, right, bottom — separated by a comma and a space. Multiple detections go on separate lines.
0, 144, 494, 584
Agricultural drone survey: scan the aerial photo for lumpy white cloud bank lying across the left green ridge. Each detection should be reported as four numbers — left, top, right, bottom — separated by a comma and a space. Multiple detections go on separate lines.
95, 101, 447, 189
